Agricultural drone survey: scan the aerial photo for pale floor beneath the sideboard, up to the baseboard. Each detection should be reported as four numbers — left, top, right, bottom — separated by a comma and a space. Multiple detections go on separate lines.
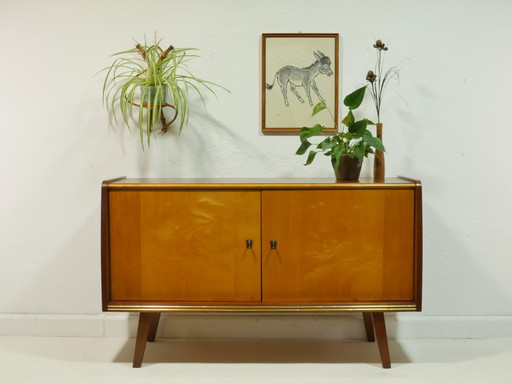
0, 337, 512, 384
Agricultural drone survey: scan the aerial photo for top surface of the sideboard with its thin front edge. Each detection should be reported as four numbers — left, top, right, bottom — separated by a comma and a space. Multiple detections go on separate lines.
105, 177, 421, 189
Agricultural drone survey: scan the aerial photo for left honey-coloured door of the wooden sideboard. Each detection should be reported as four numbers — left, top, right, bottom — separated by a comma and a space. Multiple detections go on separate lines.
109, 191, 261, 301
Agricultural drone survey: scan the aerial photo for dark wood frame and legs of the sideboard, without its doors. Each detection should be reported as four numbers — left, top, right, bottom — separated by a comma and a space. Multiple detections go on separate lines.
101, 177, 422, 368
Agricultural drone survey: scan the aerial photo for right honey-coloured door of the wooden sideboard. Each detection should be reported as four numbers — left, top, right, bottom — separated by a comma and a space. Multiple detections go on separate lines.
262, 190, 414, 302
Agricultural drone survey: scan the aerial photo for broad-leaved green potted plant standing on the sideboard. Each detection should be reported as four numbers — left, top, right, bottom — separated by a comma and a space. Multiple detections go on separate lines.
296, 86, 384, 180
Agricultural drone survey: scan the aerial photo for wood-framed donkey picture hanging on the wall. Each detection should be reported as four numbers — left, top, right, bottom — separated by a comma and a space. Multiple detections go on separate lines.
261, 33, 339, 133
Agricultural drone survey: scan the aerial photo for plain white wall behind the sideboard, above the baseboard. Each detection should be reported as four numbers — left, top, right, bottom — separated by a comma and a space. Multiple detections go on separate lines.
0, 0, 512, 336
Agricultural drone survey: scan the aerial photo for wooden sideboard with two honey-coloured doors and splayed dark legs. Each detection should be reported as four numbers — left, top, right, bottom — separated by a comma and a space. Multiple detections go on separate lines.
101, 178, 422, 368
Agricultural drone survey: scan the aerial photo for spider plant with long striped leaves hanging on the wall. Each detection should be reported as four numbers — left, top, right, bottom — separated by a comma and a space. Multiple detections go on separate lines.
103, 38, 229, 149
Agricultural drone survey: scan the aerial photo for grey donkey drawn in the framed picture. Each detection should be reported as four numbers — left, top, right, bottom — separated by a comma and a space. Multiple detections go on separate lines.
266, 51, 333, 107
